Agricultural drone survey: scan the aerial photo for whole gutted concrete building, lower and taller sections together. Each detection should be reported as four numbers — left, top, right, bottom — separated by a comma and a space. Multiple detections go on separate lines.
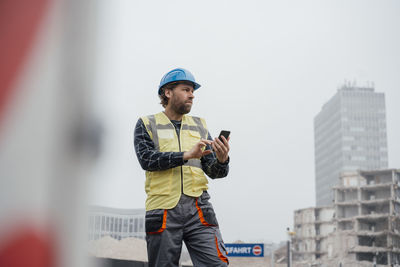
292, 169, 400, 267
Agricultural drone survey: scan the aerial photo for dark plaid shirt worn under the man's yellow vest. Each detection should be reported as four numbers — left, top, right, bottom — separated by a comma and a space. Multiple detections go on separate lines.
134, 119, 229, 179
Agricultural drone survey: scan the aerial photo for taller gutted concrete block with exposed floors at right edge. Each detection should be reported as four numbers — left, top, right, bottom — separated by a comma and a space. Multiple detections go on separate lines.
333, 169, 400, 266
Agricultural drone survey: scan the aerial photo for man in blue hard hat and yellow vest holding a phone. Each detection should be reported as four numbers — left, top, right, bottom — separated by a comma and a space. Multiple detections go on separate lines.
134, 69, 229, 267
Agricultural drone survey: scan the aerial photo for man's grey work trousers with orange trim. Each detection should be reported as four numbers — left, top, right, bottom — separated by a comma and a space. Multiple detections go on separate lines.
146, 191, 228, 267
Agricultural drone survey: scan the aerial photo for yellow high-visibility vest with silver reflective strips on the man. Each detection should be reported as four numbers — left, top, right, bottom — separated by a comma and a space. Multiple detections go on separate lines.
141, 112, 208, 210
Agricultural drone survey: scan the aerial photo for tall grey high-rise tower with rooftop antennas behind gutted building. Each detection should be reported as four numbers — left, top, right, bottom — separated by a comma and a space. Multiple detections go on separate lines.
314, 84, 388, 206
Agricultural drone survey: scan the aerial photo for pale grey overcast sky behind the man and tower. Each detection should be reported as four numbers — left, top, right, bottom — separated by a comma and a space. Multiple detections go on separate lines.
87, 0, 400, 242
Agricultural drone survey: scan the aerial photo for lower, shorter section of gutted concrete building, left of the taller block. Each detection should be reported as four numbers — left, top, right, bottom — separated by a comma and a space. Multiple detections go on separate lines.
292, 207, 335, 266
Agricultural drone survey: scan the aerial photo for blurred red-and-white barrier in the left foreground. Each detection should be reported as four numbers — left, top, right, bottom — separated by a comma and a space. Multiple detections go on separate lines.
0, 0, 100, 267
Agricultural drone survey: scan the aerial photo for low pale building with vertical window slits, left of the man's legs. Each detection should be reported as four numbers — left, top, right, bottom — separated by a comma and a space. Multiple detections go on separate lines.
88, 206, 145, 240
